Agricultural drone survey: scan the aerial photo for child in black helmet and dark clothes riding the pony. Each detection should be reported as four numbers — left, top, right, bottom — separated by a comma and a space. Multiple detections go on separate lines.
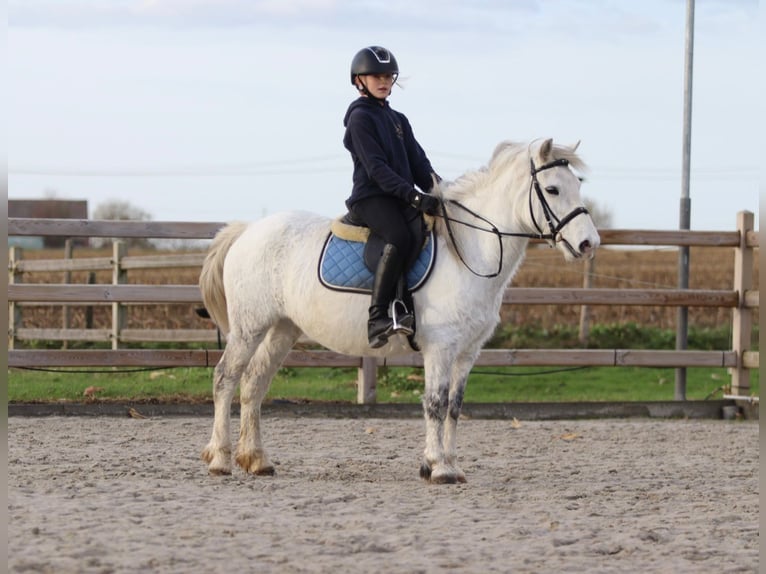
343, 46, 440, 348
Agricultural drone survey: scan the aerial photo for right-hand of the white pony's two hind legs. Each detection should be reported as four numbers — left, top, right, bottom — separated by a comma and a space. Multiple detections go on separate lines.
235, 320, 301, 475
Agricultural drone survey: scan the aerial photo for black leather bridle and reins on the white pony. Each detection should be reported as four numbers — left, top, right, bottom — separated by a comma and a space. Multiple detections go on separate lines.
441, 157, 588, 278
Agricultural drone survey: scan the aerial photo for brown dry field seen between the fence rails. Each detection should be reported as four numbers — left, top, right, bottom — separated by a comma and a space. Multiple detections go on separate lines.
10, 246, 758, 338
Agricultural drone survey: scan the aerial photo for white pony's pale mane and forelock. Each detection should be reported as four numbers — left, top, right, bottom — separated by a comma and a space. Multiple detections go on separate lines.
442, 141, 587, 200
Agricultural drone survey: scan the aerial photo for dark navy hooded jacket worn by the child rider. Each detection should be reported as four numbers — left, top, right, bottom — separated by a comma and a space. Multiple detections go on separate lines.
343, 97, 433, 209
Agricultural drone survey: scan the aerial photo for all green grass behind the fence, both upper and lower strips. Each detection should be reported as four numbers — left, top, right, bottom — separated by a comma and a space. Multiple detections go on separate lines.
8, 323, 759, 403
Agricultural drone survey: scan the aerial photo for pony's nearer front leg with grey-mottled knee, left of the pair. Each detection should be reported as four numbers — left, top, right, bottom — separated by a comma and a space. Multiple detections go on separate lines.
420, 353, 465, 484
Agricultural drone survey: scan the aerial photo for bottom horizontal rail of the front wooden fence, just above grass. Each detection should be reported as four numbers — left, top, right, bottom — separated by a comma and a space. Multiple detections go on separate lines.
8, 349, 744, 367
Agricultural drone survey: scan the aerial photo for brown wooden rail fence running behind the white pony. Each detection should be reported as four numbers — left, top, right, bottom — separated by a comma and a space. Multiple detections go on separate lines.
8, 211, 759, 403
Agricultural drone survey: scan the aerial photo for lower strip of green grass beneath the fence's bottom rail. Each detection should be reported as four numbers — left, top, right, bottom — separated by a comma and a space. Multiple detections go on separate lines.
8, 367, 759, 403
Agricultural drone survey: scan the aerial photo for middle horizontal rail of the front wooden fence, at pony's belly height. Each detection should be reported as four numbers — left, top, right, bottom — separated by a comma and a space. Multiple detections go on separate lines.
8, 283, 738, 308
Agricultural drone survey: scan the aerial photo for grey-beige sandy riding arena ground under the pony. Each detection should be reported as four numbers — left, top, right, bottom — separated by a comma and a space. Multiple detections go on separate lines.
8, 417, 759, 574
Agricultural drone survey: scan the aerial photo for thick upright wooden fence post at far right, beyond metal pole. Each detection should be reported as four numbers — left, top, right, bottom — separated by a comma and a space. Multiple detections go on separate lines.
731, 211, 755, 396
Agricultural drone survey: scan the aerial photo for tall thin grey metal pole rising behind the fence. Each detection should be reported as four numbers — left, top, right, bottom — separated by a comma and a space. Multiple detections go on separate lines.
675, 0, 694, 401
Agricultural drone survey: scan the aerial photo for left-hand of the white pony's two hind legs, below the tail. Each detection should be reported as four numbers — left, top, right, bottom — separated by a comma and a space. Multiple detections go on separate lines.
202, 336, 258, 474
